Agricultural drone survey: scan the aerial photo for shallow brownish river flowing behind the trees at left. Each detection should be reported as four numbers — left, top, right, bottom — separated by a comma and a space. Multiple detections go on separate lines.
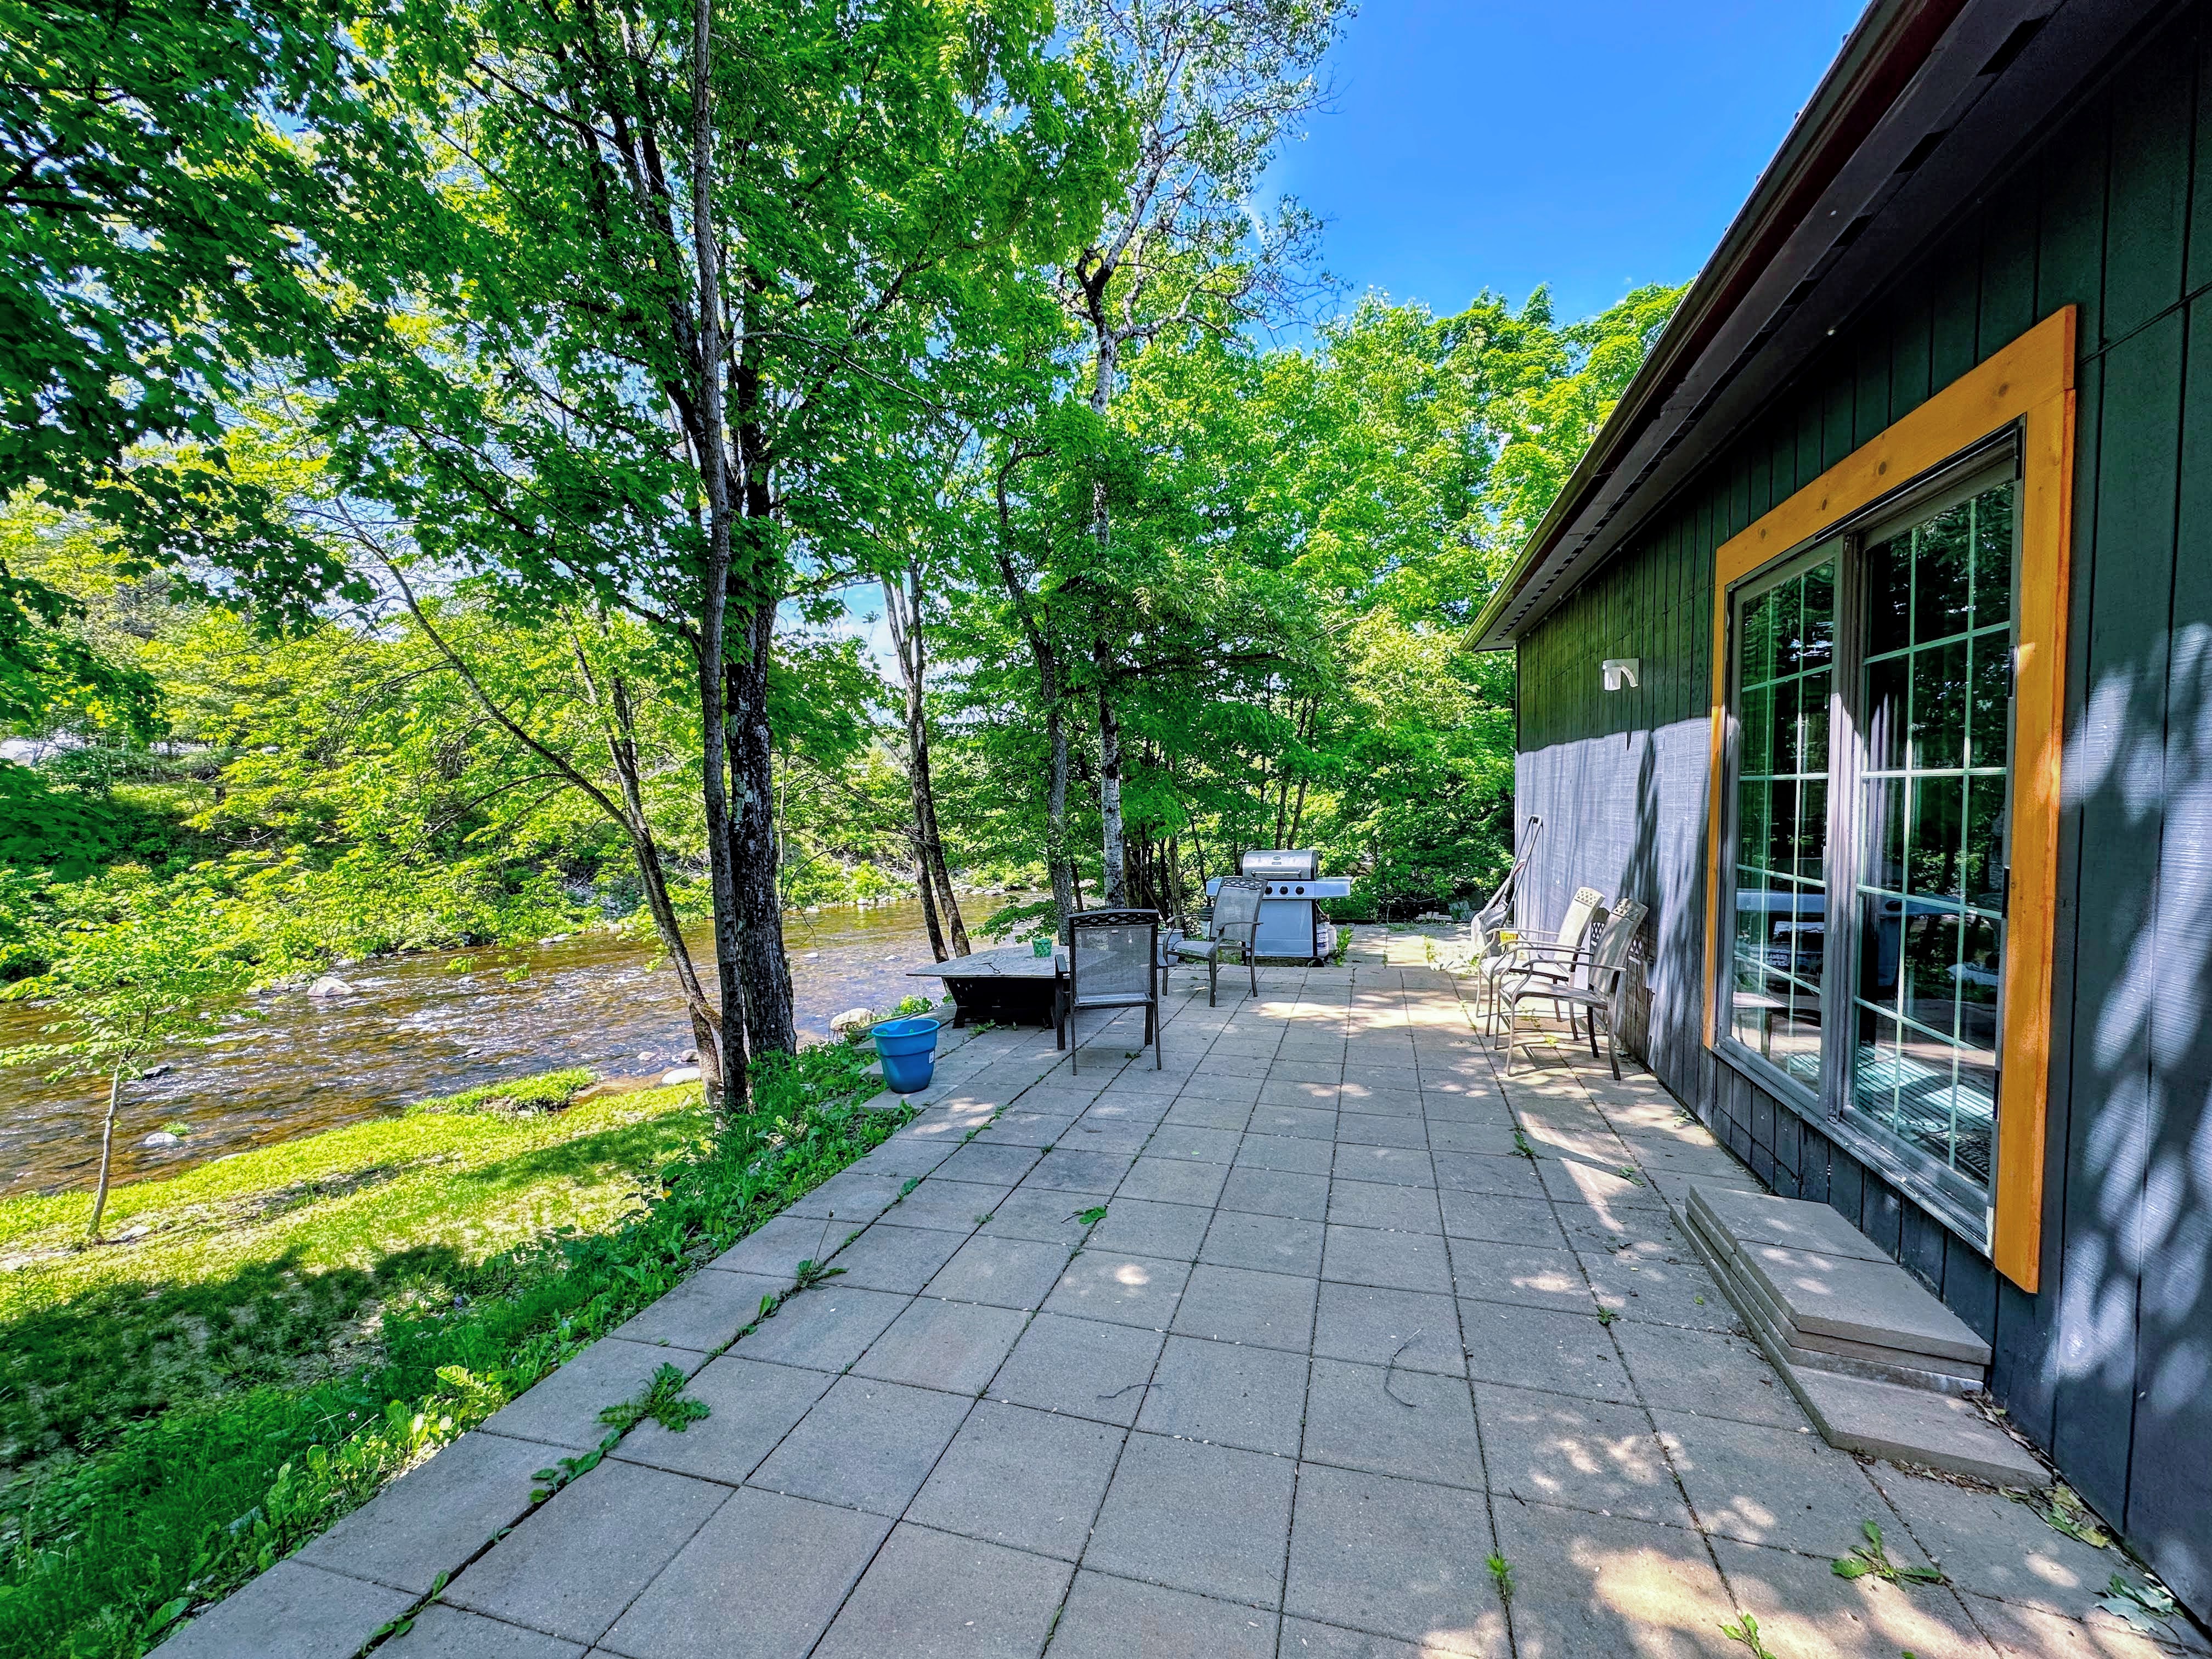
0, 905, 938, 1194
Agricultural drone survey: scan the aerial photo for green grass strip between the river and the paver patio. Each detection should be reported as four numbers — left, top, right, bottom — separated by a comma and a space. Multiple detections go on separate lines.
0, 1044, 902, 1659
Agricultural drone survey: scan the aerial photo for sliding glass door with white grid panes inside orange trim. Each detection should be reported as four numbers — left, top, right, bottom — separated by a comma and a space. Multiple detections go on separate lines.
1717, 449, 2017, 1241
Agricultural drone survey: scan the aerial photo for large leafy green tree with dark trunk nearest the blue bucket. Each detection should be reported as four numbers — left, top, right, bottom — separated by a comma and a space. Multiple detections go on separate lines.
325, 0, 1113, 1088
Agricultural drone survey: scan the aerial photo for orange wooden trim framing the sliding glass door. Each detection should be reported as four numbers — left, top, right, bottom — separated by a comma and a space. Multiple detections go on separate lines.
1706, 305, 2075, 1292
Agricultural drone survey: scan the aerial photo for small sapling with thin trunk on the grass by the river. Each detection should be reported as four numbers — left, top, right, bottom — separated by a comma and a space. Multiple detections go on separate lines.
0, 887, 250, 1243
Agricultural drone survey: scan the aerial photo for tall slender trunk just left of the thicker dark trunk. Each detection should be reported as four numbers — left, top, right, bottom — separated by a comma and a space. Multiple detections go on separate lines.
690, 0, 748, 1106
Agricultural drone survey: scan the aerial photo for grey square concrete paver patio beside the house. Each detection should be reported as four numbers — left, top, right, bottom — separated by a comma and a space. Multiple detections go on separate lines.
161, 934, 2212, 1659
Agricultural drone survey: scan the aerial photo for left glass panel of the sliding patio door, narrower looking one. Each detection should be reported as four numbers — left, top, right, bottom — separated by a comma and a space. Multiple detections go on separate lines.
1728, 560, 1836, 1088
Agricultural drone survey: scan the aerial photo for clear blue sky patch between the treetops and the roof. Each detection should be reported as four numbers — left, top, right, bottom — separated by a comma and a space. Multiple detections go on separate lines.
1267, 0, 1860, 319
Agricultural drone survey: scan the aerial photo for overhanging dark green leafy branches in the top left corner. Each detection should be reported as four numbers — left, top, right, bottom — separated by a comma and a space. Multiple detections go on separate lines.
0, 0, 438, 725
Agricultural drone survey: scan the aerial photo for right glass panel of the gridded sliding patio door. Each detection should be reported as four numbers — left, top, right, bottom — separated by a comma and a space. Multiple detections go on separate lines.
1849, 482, 2013, 1192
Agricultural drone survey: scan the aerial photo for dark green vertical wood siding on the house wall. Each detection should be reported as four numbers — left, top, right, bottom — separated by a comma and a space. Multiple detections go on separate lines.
1520, 4, 2212, 1612
